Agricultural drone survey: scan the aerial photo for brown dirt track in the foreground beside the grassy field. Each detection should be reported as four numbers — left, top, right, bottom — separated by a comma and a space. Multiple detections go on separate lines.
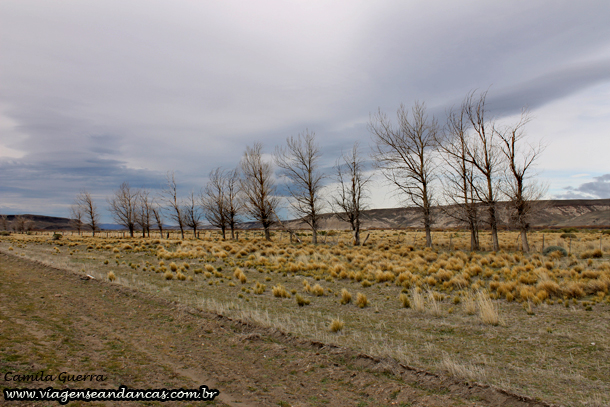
0, 253, 546, 406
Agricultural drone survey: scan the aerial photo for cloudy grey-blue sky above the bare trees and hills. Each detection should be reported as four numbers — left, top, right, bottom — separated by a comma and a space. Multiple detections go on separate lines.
0, 0, 610, 222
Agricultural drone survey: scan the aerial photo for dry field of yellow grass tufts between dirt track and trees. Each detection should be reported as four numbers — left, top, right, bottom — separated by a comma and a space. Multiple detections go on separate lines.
0, 231, 610, 406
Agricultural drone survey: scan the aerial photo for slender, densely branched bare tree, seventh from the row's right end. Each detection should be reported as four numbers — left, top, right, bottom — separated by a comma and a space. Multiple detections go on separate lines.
240, 143, 279, 240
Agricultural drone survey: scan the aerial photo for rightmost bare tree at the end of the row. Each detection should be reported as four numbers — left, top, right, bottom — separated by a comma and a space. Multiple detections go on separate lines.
498, 110, 546, 252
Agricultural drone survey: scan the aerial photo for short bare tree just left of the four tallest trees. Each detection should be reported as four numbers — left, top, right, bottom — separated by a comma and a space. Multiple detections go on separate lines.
331, 143, 371, 246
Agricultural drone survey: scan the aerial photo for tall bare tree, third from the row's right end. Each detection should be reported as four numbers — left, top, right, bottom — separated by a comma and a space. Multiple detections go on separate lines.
438, 105, 479, 251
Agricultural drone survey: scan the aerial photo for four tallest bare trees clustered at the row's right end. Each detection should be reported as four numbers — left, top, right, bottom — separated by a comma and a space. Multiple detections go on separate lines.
369, 92, 545, 251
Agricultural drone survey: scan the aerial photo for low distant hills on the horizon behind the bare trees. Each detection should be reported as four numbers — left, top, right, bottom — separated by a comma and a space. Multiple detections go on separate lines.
0, 199, 610, 231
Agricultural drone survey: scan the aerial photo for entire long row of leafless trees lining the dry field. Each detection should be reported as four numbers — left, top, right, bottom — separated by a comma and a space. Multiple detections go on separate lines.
72, 92, 544, 251
